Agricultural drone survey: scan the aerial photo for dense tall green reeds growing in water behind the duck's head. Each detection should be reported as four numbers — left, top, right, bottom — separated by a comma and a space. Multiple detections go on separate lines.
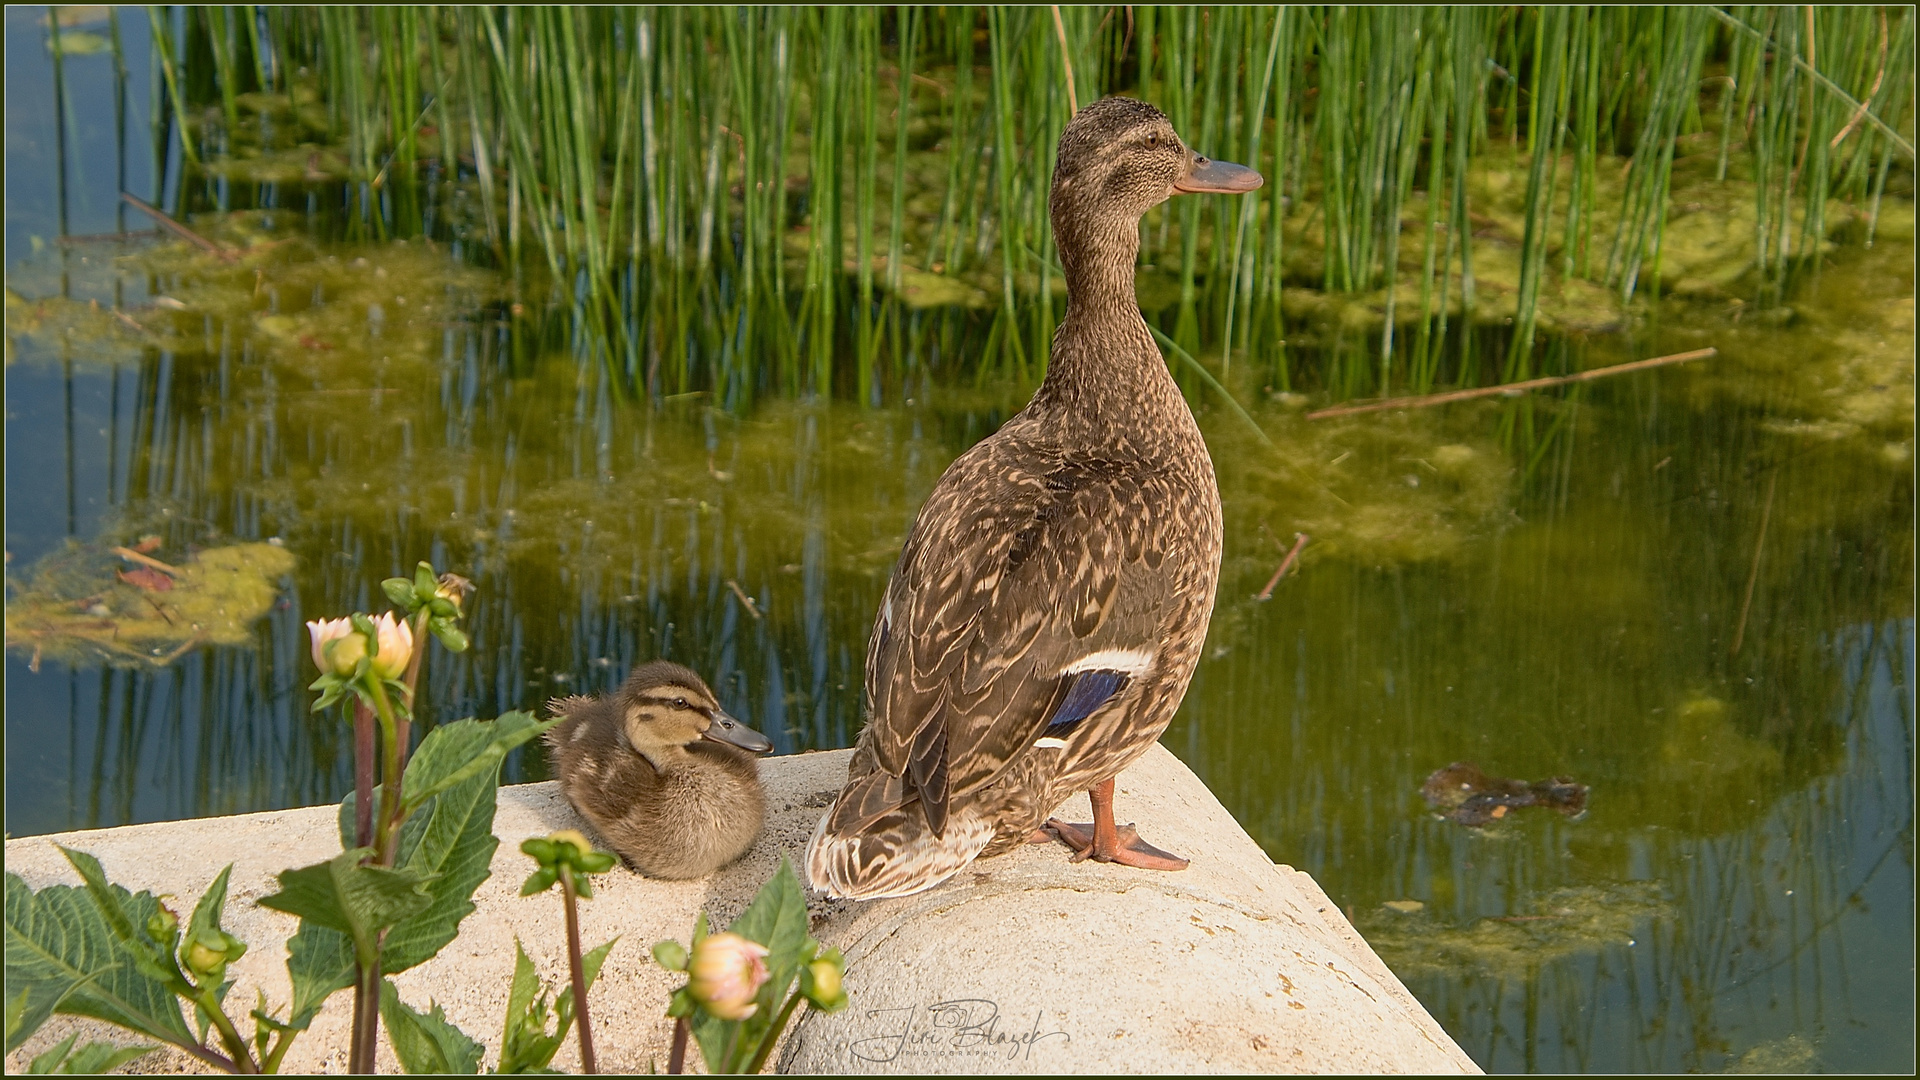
150, 6, 1914, 407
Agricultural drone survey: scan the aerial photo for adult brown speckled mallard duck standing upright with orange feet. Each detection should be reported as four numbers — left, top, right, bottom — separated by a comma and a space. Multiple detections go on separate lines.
806, 98, 1261, 899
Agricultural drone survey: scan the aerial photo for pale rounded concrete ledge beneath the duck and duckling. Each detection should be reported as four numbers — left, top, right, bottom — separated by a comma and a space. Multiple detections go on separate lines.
6, 748, 1478, 1072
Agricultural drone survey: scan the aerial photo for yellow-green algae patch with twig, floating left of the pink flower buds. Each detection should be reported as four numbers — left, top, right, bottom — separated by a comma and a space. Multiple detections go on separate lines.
6, 542, 294, 671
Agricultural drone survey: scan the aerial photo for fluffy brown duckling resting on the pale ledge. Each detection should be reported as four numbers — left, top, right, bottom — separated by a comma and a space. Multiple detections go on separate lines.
547, 659, 774, 878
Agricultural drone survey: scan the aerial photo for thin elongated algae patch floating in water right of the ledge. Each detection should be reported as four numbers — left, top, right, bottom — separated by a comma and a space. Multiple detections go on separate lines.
1361, 882, 1672, 978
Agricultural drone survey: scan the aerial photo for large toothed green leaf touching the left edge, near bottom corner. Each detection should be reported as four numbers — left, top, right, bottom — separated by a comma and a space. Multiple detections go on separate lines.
6, 863, 194, 1051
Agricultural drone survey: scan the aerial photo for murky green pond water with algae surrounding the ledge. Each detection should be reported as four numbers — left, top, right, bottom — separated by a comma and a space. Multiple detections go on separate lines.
6, 8, 1914, 1072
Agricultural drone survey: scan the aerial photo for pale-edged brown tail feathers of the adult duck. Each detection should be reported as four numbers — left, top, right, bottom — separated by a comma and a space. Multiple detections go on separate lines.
806, 773, 995, 899
